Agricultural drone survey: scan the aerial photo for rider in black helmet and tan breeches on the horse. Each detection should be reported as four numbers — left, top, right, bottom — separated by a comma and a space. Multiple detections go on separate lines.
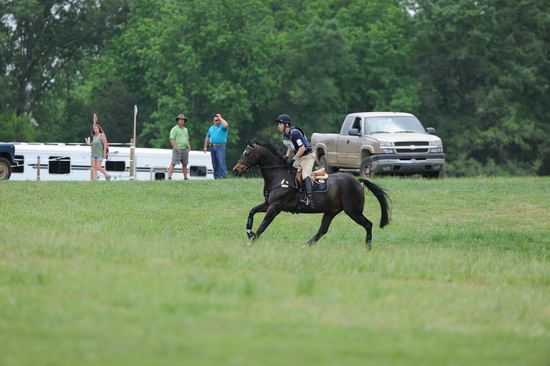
275, 114, 315, 208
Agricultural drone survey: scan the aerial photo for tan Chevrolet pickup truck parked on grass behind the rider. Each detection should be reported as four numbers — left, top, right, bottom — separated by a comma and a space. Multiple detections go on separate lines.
311, 112, 445, 178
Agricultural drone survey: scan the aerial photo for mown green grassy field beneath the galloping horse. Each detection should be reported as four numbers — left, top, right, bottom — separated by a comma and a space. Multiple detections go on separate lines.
0, 178, 550, 366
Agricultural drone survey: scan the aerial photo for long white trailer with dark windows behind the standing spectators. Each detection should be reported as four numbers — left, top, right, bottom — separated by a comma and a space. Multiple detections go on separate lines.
10, 143, 214, 181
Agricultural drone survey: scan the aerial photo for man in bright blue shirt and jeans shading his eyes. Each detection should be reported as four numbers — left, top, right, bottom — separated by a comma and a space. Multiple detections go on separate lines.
204, 113, 229, 179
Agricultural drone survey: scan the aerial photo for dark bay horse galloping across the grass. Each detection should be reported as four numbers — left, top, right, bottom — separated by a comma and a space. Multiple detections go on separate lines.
233, 141, 390, 249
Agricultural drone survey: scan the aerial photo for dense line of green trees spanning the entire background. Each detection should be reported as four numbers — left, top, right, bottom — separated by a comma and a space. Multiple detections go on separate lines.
0, 0, 550, 176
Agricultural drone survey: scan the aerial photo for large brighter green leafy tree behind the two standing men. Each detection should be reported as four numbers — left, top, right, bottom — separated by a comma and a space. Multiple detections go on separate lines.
90, 0, 282, 163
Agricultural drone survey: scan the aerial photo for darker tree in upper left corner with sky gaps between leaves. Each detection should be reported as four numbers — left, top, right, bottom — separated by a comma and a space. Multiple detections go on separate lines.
0, 0, 127, 139
